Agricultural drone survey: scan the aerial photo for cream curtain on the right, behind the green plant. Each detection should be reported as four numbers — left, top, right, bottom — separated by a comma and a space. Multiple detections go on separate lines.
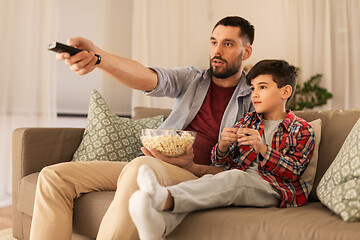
286, 0, 360, 109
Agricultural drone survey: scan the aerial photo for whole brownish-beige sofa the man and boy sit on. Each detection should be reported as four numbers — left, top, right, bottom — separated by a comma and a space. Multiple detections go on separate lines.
13, 108, 360, 240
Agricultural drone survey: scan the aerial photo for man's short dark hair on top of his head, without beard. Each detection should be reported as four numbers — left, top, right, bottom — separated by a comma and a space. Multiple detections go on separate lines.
212, 16, 255, 45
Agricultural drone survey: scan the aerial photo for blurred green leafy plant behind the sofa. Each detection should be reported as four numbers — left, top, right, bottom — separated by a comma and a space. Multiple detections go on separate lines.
287, 74, 332, 111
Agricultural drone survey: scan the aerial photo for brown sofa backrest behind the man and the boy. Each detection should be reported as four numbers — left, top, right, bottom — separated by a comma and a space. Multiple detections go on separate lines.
134, 107, 360, 201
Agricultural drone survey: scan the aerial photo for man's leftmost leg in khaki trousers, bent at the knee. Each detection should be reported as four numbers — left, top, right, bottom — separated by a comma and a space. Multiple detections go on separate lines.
30, 161, 127, 240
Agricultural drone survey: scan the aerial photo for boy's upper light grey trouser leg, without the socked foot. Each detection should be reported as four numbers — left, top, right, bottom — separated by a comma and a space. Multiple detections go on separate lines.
167, 169, 280, 213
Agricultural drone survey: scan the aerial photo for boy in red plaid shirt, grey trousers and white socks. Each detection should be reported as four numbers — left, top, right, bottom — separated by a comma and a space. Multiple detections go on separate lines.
129, 60, 315, 239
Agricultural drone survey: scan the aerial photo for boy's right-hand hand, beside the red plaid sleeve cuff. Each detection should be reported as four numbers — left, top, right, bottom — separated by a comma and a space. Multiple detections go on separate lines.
237, 128, 267, 155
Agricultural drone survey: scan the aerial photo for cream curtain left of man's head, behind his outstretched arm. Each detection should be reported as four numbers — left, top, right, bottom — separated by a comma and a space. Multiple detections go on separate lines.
131, 0, 190, 111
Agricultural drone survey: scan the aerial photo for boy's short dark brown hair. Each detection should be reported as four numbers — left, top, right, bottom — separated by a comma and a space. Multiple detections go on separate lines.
246, 60, 297, 101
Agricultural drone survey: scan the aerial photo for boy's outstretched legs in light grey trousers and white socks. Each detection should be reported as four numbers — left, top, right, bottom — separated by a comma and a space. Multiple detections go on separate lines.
129, 165, 280, 239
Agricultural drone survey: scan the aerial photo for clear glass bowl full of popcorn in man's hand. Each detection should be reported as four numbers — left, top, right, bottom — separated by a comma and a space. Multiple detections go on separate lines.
140, 129, 196, 157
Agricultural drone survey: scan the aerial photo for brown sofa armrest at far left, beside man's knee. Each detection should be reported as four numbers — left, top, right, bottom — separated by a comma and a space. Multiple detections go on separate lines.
12, 128, 84, 238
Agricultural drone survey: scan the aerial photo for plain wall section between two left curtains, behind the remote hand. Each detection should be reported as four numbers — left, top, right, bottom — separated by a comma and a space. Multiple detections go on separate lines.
53, 0, 132, 115
